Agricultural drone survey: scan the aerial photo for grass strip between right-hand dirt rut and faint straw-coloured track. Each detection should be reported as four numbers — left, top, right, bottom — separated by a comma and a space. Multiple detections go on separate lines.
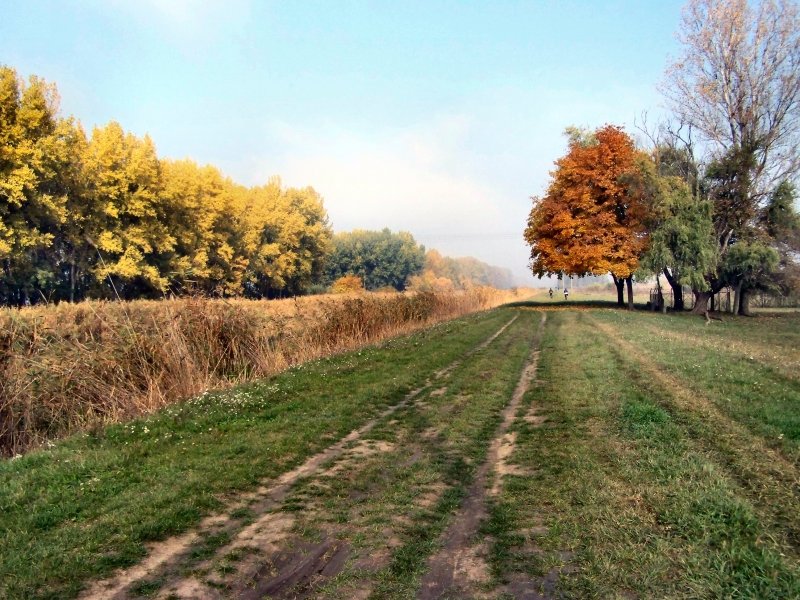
487, 313, 800, 598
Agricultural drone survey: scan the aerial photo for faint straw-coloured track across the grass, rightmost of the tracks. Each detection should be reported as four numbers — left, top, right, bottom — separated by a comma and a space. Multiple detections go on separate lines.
587, 317, 800, 554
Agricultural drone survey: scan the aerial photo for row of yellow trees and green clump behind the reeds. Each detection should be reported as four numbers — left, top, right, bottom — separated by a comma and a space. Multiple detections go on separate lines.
0, 67, 512, 305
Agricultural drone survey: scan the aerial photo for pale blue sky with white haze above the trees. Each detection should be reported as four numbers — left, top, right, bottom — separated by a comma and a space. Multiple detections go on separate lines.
0, 0, 682, 285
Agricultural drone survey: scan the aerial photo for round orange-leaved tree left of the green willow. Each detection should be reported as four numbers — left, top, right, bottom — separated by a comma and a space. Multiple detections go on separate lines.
525, 125, 647, 308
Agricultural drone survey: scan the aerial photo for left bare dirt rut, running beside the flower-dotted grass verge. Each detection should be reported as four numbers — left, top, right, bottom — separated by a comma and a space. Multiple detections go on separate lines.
79, 314, 519, 600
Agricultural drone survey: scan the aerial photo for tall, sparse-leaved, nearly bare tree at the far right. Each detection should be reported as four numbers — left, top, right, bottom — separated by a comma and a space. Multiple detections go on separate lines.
664, 0, 800, 312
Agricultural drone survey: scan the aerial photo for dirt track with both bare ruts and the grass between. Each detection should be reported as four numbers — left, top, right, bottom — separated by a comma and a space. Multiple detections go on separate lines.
82, 313, 546, 599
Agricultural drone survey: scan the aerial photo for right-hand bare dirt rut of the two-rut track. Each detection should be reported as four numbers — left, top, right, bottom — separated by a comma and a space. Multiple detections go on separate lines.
417, 313, 547, 600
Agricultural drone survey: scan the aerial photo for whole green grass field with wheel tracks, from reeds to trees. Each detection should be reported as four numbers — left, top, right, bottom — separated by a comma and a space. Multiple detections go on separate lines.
0, 302, 800, 599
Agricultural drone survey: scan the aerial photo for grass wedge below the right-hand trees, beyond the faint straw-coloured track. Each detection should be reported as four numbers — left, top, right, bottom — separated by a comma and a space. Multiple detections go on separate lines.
596, 312, 800, 463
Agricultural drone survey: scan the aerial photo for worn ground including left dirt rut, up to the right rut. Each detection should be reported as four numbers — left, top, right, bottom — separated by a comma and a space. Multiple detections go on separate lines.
87, 314, 535, 598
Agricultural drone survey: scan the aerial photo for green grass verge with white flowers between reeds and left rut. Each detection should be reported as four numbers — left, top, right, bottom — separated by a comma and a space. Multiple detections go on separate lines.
0, 311, 508, 598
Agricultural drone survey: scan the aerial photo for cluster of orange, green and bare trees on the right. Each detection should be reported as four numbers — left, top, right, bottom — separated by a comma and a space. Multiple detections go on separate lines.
525, 0, 800, 314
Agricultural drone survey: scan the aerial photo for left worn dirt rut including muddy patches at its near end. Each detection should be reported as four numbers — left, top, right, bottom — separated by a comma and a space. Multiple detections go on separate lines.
82, 315, 518, 600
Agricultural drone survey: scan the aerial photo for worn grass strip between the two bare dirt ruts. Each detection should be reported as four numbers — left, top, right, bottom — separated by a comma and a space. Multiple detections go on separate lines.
250, 313, 536, 599
